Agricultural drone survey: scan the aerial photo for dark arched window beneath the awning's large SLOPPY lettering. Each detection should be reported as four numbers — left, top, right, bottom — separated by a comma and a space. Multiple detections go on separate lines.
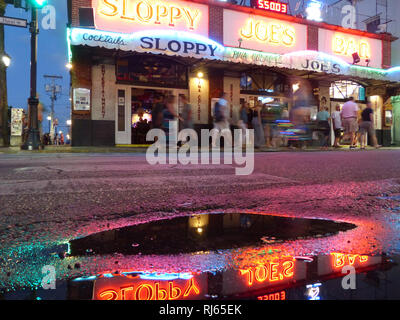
117, 55, 188, 88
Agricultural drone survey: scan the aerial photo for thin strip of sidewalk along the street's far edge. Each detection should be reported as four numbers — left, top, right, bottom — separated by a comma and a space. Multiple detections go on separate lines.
0, 145, 400, 155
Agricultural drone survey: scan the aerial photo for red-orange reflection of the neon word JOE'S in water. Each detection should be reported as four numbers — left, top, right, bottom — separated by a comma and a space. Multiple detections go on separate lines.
239, 260, 294, 286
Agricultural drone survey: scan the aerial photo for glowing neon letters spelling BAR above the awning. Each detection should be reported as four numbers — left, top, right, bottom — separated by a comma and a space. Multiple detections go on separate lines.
332, 35, 371, 59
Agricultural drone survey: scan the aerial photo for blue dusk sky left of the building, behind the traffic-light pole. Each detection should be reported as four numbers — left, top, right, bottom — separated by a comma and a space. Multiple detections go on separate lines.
5, 0, 71, 132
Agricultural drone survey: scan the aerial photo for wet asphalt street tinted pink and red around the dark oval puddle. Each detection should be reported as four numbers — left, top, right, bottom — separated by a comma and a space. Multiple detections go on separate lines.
0, 148, 400, 287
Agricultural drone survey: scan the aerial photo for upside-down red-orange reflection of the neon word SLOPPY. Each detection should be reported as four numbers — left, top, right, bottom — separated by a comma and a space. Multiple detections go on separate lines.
96, 278, 200, 300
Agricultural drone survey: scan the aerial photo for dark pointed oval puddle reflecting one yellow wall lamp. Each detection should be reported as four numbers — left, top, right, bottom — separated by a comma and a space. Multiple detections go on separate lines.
70, 213, 356, 256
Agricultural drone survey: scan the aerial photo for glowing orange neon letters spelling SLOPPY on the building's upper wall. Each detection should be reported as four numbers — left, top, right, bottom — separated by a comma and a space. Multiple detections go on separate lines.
96, 0, 201, 30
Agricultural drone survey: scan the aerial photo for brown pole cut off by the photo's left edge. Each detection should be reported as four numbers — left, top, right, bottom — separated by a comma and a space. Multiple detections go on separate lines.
0, 0, 9, 147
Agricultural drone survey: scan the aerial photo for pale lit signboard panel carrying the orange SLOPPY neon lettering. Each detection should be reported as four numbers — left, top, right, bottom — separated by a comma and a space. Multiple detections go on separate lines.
93, 0, 208, 32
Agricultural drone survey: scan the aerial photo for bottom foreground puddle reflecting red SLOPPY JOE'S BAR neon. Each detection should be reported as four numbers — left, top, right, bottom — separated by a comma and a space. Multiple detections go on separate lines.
0, 252, 400, 300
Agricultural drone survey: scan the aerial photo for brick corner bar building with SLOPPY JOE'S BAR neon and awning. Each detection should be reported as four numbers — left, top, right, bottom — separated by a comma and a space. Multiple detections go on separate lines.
67, 0, 400, 146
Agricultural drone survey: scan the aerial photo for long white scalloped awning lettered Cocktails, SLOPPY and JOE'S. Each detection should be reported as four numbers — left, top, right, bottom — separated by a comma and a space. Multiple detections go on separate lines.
68, 28, 400, 86
